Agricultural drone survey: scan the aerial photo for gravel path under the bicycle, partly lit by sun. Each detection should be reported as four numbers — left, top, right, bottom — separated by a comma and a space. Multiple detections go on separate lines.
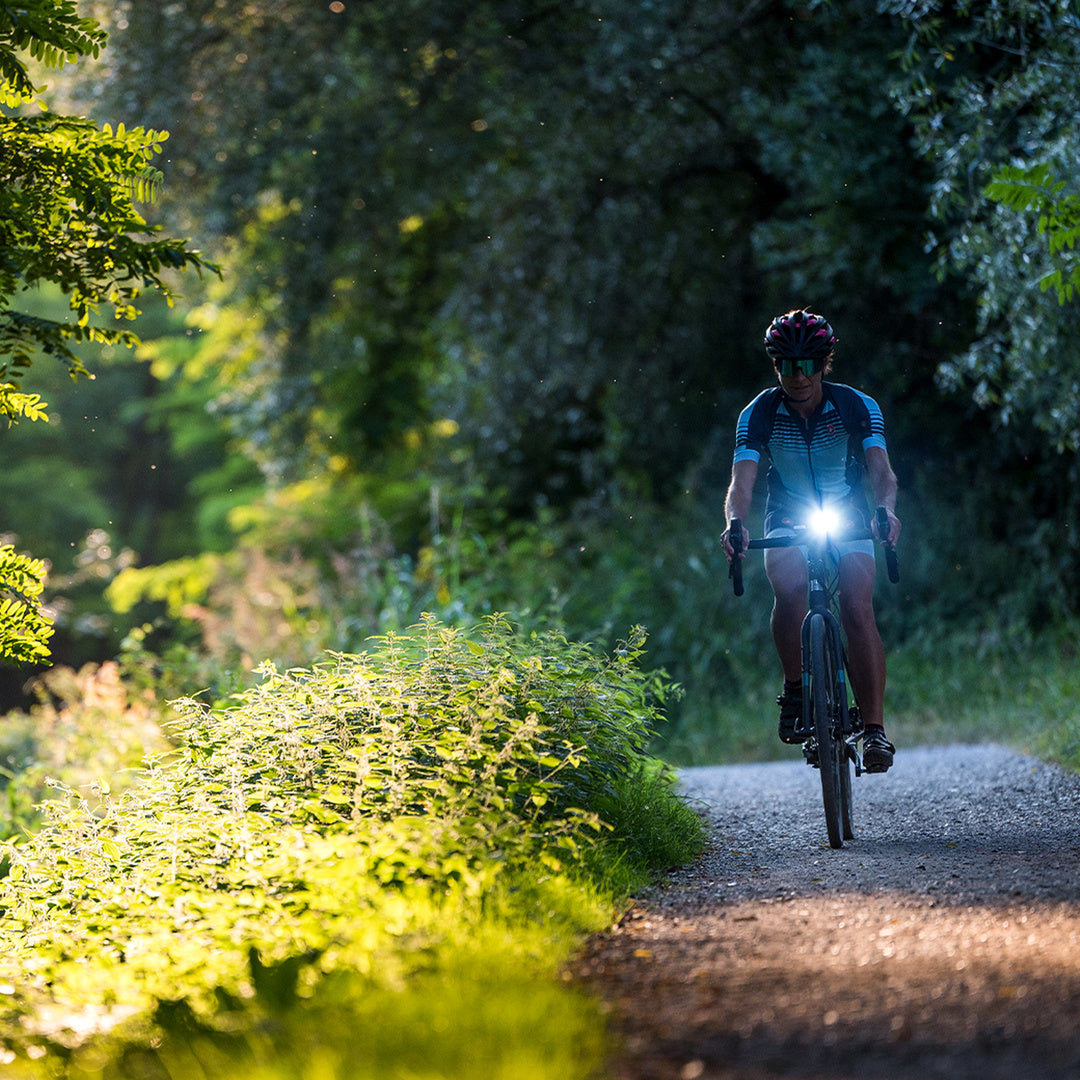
576, 746, 1080, 1080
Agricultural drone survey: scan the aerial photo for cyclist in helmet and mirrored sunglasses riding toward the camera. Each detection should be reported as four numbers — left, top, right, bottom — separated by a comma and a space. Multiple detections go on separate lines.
723, 309, 901, 772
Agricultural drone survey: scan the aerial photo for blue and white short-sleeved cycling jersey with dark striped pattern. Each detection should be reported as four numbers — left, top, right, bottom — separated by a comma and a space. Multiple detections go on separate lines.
734, 382, 886, 531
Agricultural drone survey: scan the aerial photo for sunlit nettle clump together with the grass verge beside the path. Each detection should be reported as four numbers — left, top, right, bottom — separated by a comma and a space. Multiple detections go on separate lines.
0, 618, 701, 1077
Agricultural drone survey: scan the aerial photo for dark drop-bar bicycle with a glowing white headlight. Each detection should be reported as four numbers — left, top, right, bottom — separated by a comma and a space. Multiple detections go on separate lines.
728, 507, 900, 848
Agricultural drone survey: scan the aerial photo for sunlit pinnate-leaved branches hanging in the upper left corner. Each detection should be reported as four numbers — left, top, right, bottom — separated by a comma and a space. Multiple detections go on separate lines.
0, 0, 219, 422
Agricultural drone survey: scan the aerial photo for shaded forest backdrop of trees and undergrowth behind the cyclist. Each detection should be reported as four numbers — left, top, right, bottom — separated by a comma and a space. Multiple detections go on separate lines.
0, 0, 1080, 747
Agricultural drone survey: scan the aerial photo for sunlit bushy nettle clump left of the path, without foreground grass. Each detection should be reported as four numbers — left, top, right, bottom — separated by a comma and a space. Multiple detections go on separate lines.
0, 616, 670, 1052
